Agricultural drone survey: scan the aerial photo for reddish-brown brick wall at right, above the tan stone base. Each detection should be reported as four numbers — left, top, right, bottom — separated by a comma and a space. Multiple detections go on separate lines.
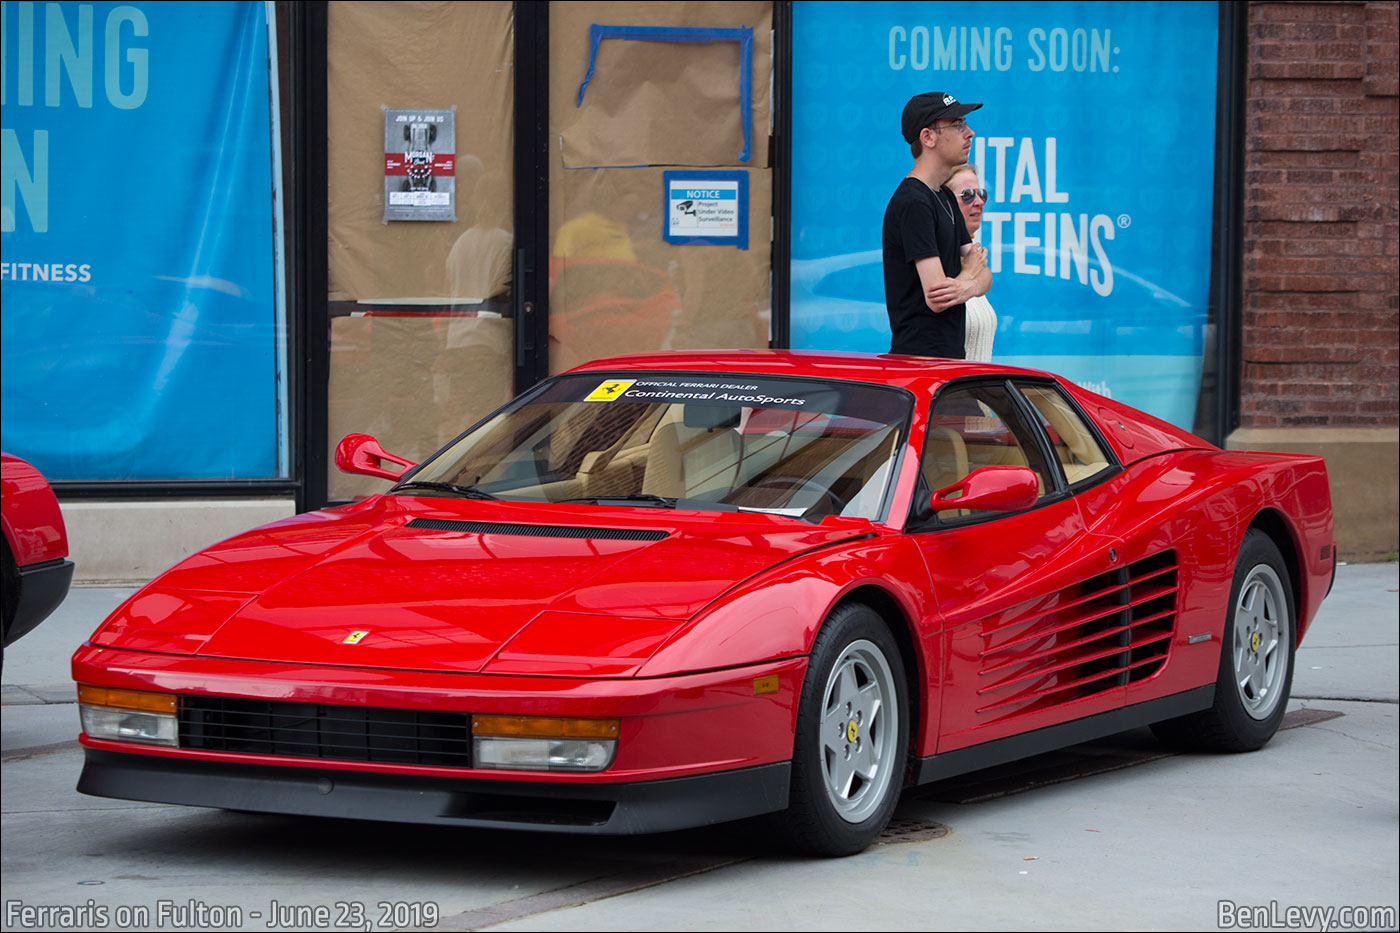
1240, 0, 1400, 427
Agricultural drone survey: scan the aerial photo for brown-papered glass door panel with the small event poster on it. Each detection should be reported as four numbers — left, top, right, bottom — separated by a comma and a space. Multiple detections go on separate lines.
326, 0, 515, 500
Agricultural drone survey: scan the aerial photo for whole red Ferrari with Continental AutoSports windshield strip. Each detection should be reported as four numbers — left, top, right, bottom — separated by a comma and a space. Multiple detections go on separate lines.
73, 352, 1336, 855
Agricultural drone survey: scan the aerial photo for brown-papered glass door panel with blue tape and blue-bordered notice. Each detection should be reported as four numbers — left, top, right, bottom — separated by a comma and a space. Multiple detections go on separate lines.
549, 1, 773, 373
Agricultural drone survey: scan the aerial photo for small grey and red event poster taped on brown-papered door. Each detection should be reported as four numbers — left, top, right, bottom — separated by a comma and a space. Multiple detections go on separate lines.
384, 106, 456, 223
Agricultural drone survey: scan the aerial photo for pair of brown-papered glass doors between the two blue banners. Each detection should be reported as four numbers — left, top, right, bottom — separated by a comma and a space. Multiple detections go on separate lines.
309, 0, 773, 502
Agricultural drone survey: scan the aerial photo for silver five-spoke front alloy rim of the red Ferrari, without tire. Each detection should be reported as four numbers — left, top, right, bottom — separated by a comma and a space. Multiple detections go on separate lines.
822, 639, 899, 822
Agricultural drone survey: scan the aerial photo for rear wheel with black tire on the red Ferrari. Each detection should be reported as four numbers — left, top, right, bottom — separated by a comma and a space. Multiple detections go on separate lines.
1152, 528, 1298, 752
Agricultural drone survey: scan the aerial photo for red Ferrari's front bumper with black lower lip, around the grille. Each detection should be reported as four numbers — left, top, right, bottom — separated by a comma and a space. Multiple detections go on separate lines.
73, 644, 806, 834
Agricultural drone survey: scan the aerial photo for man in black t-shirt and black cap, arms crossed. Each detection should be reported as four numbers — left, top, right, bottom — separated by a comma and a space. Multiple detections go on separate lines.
882, 91, 991, 360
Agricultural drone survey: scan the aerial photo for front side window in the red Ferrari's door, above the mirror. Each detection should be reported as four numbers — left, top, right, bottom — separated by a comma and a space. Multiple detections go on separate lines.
920, 384, 1054, 518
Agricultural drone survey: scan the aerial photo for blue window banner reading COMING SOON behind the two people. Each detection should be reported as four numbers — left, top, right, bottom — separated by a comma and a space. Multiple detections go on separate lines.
791, 0, 1218, 429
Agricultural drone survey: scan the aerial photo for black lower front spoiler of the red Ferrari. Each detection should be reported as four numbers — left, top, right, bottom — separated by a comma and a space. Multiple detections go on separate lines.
78, 748, 791, 835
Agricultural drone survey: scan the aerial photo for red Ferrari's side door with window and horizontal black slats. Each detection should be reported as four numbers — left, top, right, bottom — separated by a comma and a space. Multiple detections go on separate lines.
910, 380, 1124, 754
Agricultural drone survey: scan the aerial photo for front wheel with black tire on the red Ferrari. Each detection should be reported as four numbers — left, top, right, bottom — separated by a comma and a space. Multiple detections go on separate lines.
769, 602, 909, 856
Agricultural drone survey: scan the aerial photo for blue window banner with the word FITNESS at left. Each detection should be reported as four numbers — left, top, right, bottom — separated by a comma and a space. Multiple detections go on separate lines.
0, 1, 286, 481
